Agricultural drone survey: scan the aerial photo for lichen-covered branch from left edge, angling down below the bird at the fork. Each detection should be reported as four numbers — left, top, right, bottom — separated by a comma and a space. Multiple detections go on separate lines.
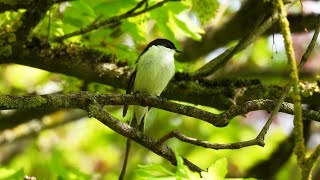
0, 92, 203, 172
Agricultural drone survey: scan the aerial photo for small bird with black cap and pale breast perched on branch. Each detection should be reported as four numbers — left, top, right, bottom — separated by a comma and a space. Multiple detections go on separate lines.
119, 39, 181, 180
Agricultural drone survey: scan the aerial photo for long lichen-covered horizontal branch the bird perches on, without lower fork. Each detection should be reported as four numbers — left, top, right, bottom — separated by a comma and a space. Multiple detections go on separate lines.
0, 91, 320, 130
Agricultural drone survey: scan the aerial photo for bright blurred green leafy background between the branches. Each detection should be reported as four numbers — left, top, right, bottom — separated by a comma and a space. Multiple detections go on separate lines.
0, 0, 320, 180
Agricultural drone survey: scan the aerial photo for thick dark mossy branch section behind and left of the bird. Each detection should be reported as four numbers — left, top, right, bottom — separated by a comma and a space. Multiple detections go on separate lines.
0, 42, 130, 88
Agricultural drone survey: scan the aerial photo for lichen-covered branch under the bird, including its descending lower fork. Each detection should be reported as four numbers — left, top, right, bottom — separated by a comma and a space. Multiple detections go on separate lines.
0, 92, 320, 172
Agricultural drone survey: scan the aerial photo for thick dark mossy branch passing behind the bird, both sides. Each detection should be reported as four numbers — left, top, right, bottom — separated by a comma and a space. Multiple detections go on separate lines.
0, 39, 320, 110
